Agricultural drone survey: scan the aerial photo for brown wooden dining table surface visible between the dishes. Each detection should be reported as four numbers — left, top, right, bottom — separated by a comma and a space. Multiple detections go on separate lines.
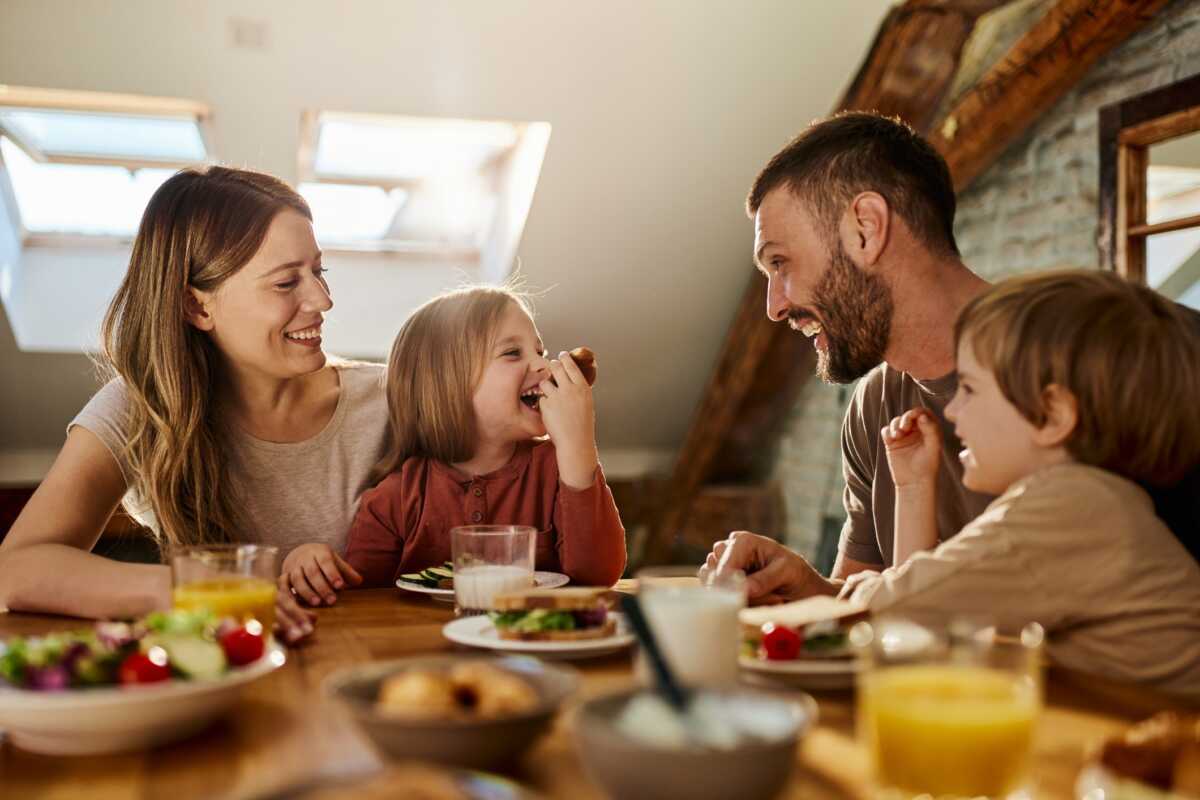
0, 582, 1185, 800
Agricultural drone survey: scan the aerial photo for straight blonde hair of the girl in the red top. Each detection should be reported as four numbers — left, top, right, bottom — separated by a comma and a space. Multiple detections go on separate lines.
371, 285, 533, 483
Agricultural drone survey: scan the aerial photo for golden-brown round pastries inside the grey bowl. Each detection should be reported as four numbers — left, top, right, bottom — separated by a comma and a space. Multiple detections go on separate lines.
376, 661, 538, 720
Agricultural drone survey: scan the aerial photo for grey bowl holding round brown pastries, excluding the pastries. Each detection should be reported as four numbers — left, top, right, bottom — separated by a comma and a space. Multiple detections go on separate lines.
323, 656, 580, 769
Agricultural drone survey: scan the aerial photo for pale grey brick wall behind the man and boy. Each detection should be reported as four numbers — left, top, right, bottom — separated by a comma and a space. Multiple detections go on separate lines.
772, 0, 1200, 563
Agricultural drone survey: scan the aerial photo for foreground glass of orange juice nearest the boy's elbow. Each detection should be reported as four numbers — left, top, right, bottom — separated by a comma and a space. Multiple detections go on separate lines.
851, 619, 1044, 800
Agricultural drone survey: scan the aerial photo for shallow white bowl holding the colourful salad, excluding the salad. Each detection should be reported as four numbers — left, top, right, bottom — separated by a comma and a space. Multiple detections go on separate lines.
0, 639, 287, 756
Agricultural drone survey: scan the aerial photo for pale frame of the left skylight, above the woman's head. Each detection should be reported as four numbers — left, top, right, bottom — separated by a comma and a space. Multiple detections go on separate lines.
0, 84, 216, 248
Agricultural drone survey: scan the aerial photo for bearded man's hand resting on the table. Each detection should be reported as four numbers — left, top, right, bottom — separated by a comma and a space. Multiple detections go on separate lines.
700, 530, 841, 606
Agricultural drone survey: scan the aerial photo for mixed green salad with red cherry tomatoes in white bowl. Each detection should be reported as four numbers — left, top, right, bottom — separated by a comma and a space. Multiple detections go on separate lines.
0, 610, 265, 691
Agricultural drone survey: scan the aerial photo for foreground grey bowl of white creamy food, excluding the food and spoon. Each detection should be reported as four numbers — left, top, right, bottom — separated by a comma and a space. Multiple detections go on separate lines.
575, 688, 817, 800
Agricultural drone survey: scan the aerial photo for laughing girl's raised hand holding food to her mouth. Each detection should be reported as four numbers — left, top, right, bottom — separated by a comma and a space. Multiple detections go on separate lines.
538, 351, 599, 489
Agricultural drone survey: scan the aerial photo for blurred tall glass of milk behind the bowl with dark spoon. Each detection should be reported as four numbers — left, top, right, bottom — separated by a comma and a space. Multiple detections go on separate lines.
636, 567, 746, 686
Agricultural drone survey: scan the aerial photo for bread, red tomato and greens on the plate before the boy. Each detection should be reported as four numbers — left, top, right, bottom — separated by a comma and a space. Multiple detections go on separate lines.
738, 597, 865, 661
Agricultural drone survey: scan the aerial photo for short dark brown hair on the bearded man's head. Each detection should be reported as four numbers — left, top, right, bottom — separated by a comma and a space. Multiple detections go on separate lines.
746, 112, 959, 255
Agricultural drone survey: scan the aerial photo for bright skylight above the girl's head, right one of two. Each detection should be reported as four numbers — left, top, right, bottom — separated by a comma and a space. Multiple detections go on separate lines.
299, 112, 550, 256
